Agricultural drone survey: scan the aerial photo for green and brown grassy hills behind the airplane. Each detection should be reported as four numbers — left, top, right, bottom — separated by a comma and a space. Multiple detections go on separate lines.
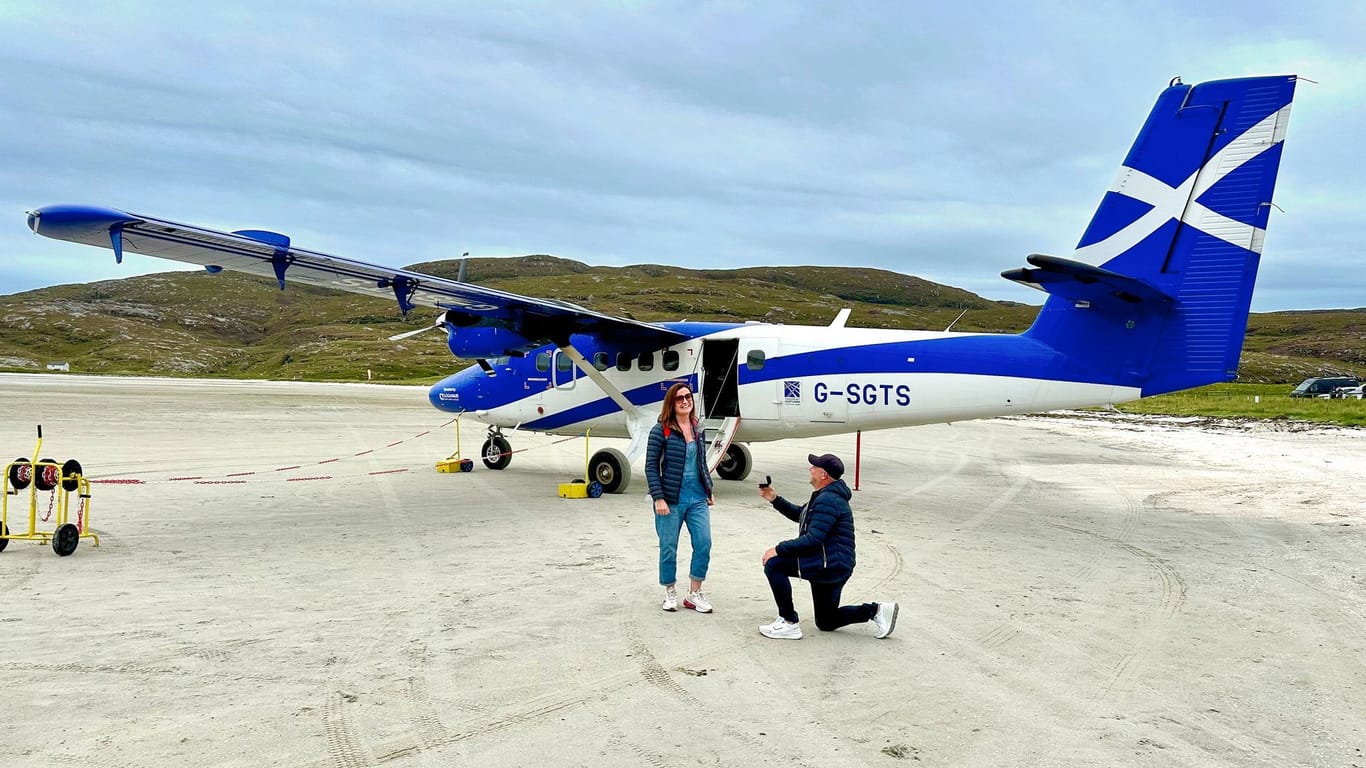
0, 256, 1366, 384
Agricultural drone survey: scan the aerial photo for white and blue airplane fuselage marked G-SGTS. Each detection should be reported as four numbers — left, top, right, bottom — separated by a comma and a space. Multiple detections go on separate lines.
429, 323, 1141, 443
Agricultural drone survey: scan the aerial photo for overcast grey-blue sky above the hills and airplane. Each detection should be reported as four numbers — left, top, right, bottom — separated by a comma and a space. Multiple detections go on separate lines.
0, 0, 1366, 312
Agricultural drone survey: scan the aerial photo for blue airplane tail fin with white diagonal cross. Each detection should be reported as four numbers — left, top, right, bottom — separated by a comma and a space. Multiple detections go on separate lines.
1001, 75, 1295, 396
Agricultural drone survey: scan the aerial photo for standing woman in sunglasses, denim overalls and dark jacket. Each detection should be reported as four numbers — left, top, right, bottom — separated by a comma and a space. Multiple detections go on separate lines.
645, 383, 716, 614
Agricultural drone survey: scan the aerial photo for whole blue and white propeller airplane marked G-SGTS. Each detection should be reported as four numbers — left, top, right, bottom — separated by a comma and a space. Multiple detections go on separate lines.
29, 75, 1296, 493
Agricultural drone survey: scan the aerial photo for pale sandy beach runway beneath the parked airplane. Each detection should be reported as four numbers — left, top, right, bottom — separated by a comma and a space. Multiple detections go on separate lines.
0, 374, 1366, 768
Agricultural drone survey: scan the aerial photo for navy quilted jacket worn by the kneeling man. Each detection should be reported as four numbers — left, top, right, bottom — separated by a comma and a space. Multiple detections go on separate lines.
773, 480, 854, 582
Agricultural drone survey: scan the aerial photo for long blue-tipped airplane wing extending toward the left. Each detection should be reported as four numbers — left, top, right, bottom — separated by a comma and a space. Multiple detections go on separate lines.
21, 205, 686, 348
